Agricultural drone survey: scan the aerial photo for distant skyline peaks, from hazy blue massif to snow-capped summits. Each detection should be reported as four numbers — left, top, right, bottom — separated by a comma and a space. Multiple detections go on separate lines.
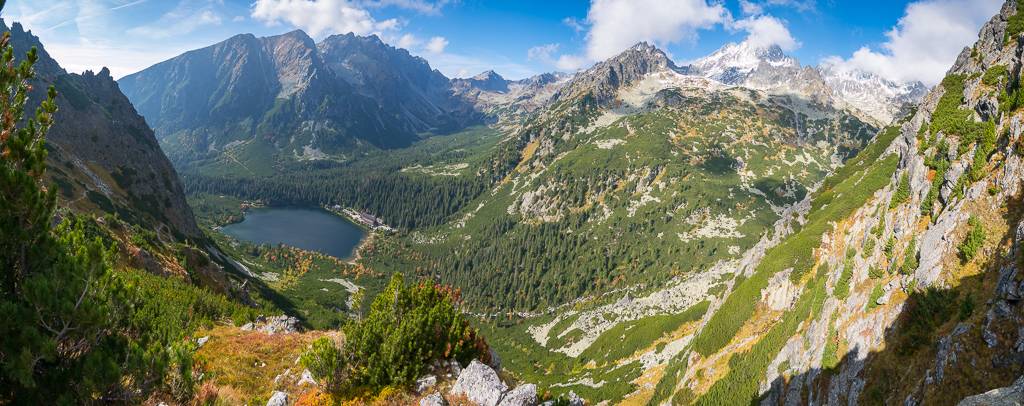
119, 31, 926, 170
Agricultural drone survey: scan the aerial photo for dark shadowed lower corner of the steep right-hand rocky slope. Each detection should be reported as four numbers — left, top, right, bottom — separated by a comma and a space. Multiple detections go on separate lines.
761, 192, 1024, 406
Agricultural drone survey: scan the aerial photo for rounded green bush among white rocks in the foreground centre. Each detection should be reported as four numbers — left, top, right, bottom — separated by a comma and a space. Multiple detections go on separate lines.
301, 274, 489, 393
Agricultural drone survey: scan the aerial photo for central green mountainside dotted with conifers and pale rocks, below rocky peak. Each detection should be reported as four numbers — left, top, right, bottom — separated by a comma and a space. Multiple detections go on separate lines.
395, 44, 874, 311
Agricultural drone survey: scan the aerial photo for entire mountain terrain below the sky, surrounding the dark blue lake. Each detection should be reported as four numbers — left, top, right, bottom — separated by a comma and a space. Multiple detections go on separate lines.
12, 0, 1024, 406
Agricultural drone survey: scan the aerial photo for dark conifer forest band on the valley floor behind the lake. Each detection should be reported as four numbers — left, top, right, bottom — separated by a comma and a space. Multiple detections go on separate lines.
182, 168, 488, 230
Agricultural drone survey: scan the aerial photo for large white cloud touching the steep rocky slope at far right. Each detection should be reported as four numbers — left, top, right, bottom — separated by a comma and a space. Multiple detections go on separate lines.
823, 0, 1002, 85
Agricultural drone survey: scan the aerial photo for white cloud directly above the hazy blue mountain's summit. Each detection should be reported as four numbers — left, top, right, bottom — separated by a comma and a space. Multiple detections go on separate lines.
252, 0, 399, 37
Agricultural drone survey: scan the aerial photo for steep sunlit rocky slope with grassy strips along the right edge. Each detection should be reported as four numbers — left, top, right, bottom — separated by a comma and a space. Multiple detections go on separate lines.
630, 1, 1024, 404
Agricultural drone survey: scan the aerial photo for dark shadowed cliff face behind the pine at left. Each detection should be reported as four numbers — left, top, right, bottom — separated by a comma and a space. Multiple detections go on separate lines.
0, 23, 202, 239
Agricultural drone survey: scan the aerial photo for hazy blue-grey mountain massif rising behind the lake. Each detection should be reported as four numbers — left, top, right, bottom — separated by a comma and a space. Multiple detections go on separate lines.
119, 31, 479, 170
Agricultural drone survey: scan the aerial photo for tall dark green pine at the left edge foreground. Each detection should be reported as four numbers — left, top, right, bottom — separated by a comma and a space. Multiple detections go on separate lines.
0, 24, 151, 404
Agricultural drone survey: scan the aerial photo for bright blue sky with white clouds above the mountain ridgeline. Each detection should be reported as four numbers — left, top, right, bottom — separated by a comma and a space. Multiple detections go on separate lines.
2, 0, 1001, 84
